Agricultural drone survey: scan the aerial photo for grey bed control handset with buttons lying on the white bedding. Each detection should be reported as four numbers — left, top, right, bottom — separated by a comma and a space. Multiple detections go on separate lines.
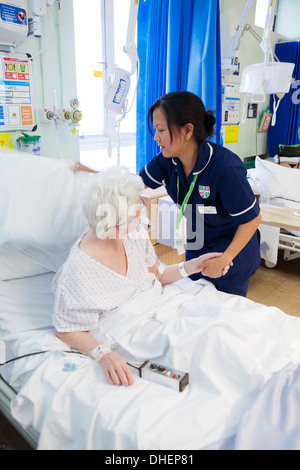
129, 360, 189, 392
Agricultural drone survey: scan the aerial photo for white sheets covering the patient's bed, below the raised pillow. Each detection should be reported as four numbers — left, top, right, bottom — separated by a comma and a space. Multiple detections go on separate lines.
0, 274, 300, 450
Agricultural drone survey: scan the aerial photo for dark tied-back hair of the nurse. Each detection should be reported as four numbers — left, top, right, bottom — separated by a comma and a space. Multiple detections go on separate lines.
148, 91, 216, 143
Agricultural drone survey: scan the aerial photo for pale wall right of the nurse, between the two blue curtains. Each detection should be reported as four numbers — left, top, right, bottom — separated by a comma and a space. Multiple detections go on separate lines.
220, 0, 282, 159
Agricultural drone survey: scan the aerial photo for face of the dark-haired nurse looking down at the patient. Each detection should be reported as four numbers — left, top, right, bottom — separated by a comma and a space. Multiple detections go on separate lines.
153, 108, 185, 158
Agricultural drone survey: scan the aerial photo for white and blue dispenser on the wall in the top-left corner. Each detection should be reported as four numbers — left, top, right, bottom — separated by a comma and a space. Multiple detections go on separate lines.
0, 0, 28, 47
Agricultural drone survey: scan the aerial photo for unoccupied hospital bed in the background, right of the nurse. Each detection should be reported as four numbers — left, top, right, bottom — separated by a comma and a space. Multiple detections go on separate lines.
248, 157, 300, 268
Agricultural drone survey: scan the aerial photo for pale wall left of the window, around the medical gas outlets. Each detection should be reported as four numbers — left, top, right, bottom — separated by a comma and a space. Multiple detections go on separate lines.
4, 0, 80, 160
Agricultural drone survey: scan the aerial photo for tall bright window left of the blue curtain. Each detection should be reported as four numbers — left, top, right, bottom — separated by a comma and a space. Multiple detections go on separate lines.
73, 0, 136, 167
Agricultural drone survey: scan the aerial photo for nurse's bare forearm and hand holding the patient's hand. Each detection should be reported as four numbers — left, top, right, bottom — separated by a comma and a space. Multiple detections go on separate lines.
202, 214, 261, 278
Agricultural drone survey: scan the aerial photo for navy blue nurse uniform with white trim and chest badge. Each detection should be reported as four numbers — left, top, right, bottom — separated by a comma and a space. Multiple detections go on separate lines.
140, 142, 261, 296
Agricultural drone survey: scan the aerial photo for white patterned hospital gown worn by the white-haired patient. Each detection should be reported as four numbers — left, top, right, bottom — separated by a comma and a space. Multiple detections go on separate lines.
52, 230, 156, 332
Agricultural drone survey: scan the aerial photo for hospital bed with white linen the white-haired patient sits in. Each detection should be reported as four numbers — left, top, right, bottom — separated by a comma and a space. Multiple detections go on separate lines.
0, 154, 300, 452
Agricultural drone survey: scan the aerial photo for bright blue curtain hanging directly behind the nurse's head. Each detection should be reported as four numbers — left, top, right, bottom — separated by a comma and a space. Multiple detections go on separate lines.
136, 0, 222, 171
